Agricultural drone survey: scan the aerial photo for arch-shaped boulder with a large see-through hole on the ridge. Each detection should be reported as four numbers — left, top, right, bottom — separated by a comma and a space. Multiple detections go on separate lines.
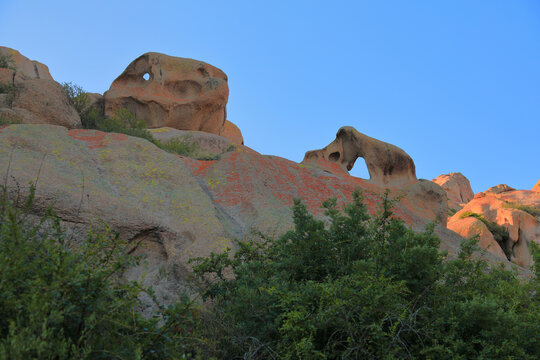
302, 126, 416, 187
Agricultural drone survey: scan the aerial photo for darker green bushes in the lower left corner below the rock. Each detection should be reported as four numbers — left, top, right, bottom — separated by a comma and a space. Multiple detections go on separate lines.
0, 186, 202, 360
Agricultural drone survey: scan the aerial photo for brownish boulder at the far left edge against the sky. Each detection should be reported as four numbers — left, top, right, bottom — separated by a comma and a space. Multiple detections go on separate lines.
0, 47, 81, 128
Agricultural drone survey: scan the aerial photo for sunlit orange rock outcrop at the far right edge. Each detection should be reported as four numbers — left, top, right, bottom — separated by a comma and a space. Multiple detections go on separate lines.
448, 185, 540, 268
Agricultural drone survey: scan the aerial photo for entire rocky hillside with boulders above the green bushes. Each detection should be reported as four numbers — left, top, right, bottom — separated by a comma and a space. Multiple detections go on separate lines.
0, 48, 540, 300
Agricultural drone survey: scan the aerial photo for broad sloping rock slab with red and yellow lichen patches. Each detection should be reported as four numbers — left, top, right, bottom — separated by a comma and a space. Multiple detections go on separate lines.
0, 125, 520, 301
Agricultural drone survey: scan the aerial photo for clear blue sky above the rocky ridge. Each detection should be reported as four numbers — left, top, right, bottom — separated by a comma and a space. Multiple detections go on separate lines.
0, 0, 540, 192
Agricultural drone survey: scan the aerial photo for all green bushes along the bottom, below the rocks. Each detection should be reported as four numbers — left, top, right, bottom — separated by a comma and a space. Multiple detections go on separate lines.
0, 187, 540, 360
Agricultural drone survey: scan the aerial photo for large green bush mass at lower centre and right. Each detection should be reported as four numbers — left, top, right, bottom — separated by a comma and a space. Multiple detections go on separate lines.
194, 193, 540, 359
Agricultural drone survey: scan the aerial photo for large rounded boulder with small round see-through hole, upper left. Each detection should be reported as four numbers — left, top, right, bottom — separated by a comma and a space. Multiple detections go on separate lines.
104, 52, 243, 144
